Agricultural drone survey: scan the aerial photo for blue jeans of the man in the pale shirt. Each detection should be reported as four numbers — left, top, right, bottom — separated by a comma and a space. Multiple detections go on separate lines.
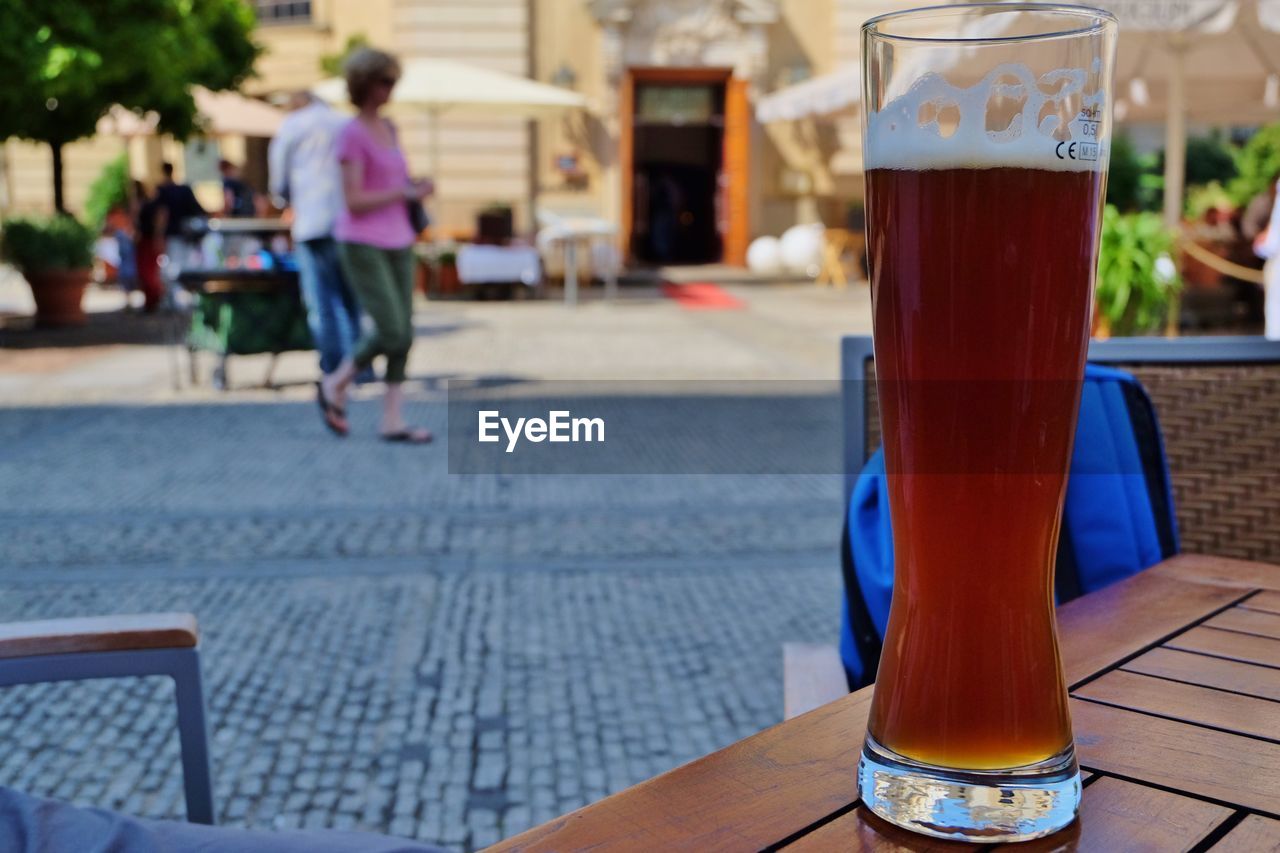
294, 237, 360, 373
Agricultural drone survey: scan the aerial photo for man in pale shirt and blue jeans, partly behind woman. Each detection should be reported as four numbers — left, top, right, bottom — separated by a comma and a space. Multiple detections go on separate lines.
268, 92, 360, 373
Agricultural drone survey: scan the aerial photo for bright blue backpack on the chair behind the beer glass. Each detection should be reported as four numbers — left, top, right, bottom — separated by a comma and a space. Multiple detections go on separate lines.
840, 364, 1178, 690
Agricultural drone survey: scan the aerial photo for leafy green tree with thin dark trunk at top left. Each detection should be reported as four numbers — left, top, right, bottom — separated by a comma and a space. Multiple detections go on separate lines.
0, 0, 259, 211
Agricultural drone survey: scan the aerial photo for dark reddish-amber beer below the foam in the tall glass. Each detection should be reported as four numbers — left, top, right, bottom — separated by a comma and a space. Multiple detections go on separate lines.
867, 162, 1102, 770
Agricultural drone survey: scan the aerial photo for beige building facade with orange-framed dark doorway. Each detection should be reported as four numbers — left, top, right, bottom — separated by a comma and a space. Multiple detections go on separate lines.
5, 0, 885, 263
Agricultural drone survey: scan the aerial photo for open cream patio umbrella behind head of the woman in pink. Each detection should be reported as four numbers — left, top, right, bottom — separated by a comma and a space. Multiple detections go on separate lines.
311, 59, 586, 175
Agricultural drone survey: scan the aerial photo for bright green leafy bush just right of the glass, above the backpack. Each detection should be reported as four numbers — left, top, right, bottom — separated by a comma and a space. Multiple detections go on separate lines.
1094, 205, 1181, 334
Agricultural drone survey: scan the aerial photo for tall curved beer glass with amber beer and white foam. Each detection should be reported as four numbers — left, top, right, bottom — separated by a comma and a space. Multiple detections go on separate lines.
859, 3, 1116, 841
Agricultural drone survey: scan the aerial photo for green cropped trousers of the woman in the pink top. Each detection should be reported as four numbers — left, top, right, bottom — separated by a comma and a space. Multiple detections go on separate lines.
338, 242, 413, 383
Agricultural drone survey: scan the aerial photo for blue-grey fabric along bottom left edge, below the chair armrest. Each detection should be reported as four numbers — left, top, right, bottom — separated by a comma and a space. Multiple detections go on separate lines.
0, 786, 444, 853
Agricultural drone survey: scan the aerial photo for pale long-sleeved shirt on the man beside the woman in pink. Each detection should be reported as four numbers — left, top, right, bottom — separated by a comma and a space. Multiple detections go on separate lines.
268, 101, 348, 241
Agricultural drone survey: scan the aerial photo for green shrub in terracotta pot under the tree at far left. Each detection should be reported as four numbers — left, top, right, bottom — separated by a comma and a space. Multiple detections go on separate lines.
0, 214, 93, 325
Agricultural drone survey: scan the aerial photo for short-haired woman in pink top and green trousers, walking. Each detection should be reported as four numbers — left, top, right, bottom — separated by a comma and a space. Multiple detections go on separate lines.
317, 47, 433, 444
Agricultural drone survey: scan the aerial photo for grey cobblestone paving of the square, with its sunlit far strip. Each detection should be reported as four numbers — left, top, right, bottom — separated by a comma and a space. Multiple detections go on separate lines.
0, 275, 865, 850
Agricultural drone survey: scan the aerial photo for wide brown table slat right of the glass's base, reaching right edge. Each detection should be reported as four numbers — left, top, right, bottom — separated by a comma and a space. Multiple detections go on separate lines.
1071, 699, 1280, 815
